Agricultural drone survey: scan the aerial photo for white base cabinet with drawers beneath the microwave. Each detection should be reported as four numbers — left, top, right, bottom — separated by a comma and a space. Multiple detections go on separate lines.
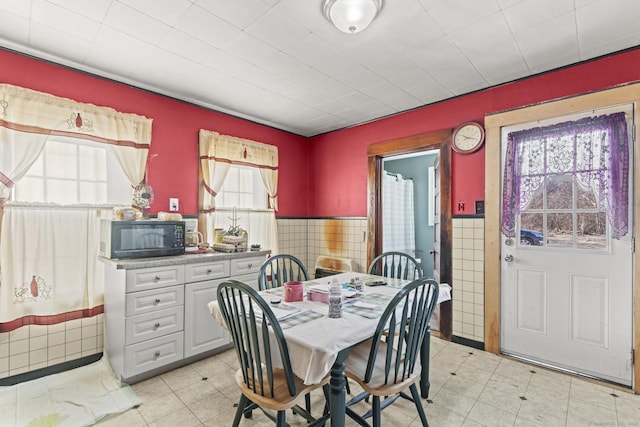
105, 252, 268, 383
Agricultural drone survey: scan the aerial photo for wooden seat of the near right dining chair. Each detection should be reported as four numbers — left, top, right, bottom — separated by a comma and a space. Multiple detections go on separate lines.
345, 340, 421, 396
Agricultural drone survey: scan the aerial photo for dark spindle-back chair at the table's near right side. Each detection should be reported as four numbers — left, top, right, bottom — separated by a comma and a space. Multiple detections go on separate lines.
345, 278, 438, 427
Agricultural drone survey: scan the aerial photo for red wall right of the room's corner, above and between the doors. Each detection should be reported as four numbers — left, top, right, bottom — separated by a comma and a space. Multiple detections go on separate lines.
309, 49, 640, 216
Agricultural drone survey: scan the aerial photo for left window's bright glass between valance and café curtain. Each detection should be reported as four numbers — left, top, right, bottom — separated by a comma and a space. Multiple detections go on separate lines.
12, 136, 131, 205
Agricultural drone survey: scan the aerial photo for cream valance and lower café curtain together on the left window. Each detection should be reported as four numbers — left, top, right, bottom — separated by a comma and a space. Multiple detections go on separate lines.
0, 84, 151, 332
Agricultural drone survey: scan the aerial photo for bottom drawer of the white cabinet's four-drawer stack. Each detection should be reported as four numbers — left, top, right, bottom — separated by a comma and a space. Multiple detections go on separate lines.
123, 332, 184, 378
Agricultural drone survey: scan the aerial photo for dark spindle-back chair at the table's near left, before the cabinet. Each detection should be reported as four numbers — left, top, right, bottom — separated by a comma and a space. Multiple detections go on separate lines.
218, 280, 329, 427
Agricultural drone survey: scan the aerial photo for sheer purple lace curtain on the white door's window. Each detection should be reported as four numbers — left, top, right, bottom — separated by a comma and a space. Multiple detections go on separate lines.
502, 112, 629, 239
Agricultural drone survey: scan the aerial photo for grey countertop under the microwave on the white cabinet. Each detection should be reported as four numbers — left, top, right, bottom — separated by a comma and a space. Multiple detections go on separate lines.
98, 250, 271, 270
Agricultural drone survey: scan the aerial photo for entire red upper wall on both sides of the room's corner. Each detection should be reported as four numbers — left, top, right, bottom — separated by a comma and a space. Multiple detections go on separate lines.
0, 49, 640, 217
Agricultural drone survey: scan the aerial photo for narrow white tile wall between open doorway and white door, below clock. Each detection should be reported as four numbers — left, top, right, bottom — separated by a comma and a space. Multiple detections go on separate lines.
451, 218, 484, 342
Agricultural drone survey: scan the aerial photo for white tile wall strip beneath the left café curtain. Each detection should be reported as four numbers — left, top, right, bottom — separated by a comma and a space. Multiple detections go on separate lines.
0, 314, 104, 378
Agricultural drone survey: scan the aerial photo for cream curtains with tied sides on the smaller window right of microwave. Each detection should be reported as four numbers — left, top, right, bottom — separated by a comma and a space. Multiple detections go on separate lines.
199, 129, 278, 253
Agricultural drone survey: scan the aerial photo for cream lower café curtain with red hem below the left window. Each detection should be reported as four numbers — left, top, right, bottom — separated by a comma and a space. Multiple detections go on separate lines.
0, 203, 112, 326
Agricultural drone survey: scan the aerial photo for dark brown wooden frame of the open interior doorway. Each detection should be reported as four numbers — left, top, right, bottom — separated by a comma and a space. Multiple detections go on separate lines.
367, 129, 453, 340
